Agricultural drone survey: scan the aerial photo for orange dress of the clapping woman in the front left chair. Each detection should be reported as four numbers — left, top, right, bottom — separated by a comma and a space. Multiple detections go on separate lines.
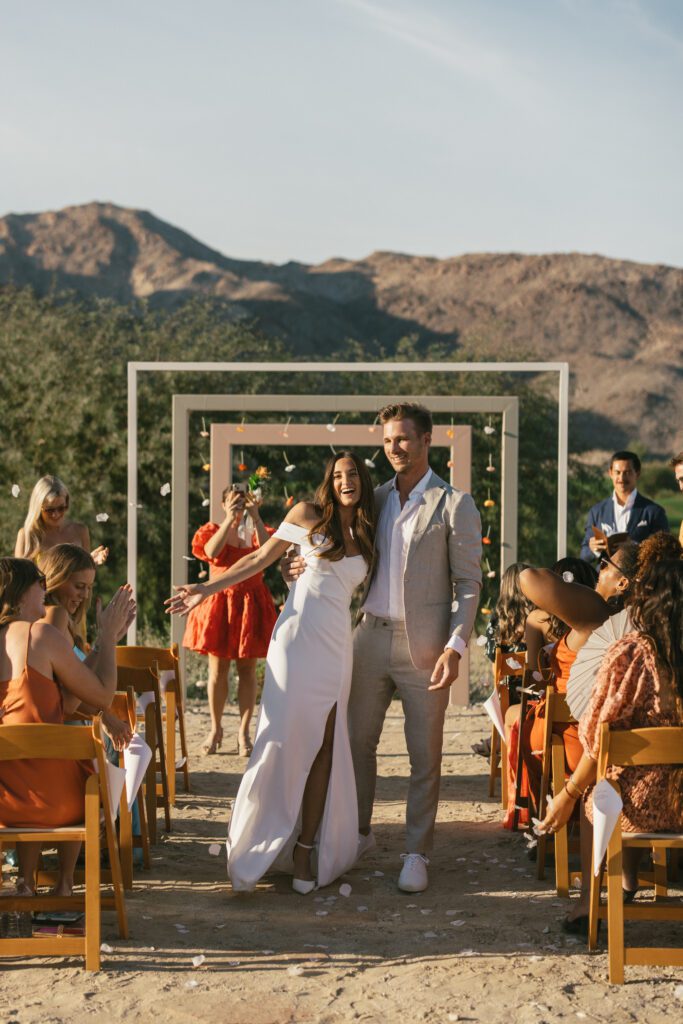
0, 629, 94, 828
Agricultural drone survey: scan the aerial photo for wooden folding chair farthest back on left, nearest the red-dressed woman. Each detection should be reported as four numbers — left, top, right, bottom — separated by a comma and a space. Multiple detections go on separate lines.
116, 643, 189, 806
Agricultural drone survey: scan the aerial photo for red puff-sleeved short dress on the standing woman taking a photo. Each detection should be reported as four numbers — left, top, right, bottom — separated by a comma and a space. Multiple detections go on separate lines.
182, 522, 278, 658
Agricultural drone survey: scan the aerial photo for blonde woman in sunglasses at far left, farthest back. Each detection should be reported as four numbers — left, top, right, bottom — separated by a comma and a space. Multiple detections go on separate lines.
14, 476, 109, 565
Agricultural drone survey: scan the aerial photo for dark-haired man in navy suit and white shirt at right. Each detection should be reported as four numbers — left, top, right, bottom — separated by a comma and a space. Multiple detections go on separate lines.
581, 452, 669, 561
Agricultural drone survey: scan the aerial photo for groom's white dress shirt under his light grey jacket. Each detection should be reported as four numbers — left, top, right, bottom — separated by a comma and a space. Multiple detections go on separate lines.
364, 469, 467, 655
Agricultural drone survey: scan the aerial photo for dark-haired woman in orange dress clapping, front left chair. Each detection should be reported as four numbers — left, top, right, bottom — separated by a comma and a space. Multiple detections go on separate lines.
0, 558, 131, 896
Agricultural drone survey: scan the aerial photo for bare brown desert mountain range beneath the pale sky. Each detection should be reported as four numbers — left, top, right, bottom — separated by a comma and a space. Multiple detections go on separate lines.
0, 203, 683, 454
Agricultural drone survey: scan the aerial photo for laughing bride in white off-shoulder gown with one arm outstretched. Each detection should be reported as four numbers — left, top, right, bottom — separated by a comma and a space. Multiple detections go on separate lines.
166, 452, 375, 894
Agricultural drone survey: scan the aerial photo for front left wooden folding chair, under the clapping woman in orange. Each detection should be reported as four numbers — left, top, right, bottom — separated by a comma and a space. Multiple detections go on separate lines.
0, 721, 128, 971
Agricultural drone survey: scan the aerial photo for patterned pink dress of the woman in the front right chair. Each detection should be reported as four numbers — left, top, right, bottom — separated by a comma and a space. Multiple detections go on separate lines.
579, 633, 683, 831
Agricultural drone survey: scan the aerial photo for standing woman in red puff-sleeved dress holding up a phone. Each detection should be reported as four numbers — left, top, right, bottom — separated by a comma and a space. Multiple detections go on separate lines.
182, 487, 278, 757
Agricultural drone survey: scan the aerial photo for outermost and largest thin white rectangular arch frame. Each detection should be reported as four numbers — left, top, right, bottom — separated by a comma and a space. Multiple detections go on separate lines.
127, 361, 569, 643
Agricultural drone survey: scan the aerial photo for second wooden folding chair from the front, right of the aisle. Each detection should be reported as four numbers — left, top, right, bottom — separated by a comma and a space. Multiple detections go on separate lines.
537, 686, 578, 898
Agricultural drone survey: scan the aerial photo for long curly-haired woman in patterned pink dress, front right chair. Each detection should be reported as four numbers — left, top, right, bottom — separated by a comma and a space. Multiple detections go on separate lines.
542, 549, 683, 933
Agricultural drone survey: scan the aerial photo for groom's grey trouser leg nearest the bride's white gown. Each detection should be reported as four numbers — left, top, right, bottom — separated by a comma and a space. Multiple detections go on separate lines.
348, 623, 395, 836
